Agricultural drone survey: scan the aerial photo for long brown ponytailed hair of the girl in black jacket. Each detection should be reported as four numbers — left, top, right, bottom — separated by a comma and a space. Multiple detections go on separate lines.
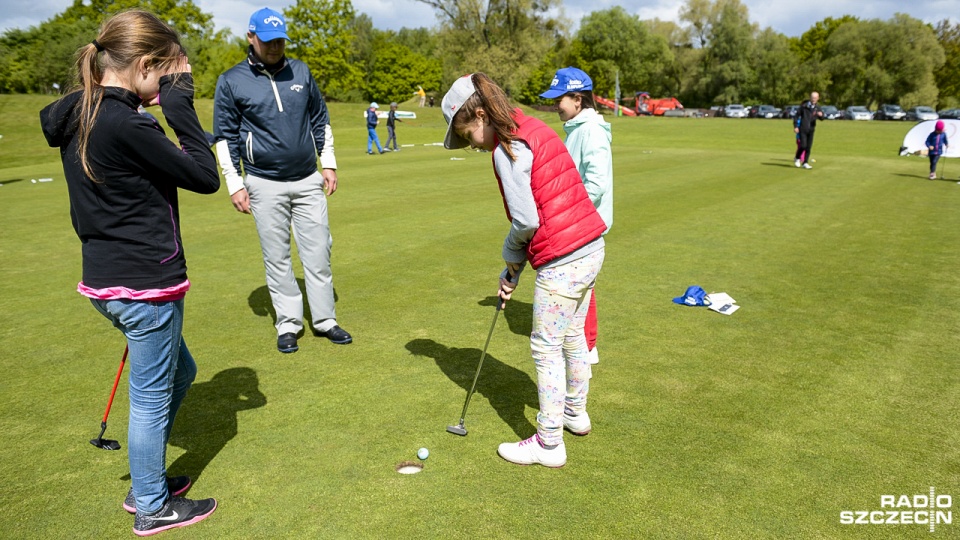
74, 9, 184, 182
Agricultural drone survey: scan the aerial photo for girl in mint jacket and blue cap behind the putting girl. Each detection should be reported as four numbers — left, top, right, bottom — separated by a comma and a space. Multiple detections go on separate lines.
540, 67, 613, 364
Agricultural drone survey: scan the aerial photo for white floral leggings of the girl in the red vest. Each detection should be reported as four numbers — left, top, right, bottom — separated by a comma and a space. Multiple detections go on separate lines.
530, 248, 603, 445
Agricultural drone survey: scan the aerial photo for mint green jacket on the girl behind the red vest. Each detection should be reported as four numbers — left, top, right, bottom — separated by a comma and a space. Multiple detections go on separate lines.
563, 109, 613, 234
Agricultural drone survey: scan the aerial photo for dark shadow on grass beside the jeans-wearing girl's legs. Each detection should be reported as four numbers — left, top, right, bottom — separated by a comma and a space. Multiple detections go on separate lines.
163, 367, 267, 482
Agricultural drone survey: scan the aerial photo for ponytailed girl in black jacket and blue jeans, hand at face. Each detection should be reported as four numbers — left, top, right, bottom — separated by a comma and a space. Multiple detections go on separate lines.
40, 10, 220, 536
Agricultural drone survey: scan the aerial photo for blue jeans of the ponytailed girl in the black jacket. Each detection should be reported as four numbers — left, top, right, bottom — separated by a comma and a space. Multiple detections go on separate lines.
91, 299, 197, 514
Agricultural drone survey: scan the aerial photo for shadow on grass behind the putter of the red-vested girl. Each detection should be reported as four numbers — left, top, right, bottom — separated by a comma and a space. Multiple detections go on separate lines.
406, 339, 540, 439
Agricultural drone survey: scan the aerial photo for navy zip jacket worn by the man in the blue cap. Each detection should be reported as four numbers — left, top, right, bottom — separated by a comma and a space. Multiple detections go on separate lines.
213, 52, 330, 188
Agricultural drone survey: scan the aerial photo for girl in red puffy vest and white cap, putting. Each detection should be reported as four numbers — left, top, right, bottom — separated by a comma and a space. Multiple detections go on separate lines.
442, 73, 606, 467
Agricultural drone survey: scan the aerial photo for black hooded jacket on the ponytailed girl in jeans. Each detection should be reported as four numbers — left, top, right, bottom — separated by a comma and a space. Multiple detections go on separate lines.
40, 74, 220, 291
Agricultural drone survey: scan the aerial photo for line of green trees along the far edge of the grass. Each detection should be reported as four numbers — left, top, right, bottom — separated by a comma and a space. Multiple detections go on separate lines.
0, 0, 960, 108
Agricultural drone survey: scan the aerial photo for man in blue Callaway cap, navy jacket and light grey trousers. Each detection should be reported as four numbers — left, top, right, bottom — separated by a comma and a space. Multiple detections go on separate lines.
213, 8, 353, 353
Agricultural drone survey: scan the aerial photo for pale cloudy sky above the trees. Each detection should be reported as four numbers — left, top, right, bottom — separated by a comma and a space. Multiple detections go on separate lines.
0, 0, 960, 36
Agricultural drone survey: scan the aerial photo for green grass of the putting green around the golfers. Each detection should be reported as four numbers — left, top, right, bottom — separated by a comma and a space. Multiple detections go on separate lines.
0, 96, 960, 539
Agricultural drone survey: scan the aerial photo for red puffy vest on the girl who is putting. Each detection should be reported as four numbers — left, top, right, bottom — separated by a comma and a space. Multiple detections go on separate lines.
493, 109, 607, 268
